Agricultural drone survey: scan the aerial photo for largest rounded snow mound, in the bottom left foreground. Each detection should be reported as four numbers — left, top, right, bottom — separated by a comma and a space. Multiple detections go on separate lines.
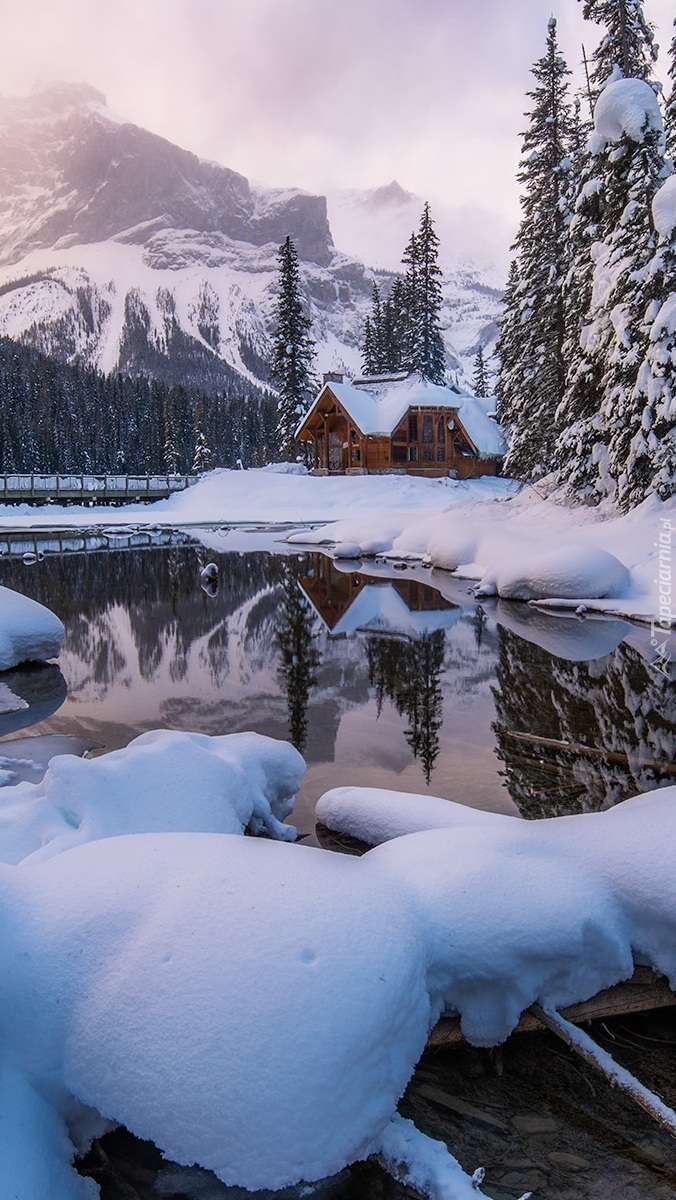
6, 834, 431, 1200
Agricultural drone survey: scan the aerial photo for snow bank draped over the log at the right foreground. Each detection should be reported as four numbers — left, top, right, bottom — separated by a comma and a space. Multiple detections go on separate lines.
317, 787, 676, 1045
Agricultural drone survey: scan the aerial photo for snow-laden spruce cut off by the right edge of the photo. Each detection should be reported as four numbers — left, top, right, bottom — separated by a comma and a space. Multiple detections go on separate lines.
618, 175, 676, 508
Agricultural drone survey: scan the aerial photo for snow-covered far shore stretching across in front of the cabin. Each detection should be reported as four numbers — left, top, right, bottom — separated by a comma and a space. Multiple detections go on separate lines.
0, 466, 676, 624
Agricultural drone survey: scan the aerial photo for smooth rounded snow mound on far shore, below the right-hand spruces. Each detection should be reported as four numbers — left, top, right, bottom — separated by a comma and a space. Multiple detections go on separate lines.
477, 545, 630, 600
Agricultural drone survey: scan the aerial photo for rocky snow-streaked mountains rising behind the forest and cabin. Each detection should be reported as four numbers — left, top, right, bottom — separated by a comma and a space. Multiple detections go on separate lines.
0, 84, 499, 390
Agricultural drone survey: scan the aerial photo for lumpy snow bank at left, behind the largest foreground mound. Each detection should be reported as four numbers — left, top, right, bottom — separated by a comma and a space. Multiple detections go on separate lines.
0, 730, 305, 863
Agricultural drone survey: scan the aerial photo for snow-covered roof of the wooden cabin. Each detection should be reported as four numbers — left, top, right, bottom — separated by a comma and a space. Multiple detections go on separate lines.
297, 372, 507, 458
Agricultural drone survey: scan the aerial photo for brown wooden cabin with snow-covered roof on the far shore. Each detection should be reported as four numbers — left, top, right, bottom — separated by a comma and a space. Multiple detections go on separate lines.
295, 373, 507, 479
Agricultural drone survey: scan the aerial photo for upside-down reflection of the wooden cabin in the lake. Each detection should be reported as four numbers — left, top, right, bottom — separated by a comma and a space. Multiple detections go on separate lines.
300, 554, 460, 637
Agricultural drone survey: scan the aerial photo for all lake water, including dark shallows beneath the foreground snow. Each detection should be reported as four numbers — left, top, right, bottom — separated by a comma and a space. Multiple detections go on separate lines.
0, 529, 676, 1200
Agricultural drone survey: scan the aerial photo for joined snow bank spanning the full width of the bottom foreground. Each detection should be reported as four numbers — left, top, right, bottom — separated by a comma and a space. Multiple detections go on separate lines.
0, 772, 676, 1200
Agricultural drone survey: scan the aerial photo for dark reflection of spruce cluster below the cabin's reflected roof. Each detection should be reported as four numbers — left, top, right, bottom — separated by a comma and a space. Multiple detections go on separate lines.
366, 629, 445, 784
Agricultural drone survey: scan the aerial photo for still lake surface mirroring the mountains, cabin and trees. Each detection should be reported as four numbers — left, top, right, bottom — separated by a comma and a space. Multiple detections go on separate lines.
2, 539, 676, 832
